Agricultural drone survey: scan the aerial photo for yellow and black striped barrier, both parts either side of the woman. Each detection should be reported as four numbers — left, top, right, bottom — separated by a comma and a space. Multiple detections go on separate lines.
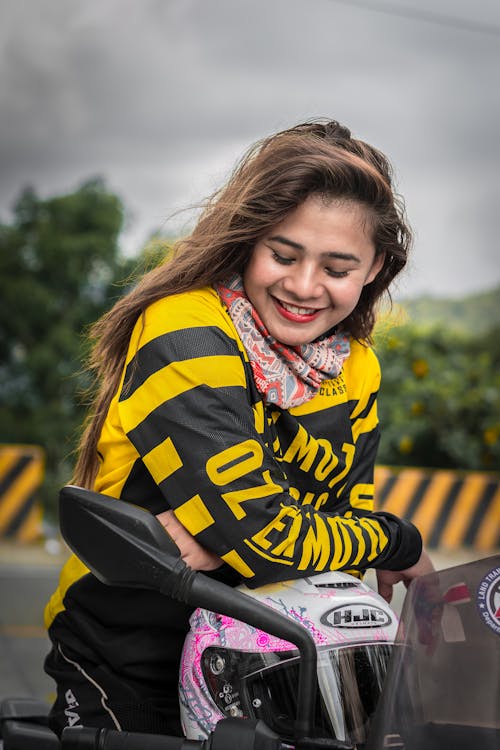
0, 445, 500, 552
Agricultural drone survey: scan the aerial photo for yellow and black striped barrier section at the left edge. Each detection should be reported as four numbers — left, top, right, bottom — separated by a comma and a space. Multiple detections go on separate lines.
0, 445, 44, 542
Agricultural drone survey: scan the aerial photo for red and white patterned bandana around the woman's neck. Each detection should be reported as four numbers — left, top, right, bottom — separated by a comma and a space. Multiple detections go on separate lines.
215, 275, 350, 409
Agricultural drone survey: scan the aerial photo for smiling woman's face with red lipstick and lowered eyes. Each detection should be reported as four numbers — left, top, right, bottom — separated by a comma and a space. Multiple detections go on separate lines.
243, 196, 384, 346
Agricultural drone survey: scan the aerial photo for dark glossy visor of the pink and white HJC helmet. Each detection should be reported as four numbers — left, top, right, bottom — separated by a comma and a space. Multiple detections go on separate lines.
203, 643, 392, 744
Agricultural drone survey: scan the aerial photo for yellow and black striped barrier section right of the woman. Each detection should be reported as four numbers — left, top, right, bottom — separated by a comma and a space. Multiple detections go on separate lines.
375, 466, 500, 552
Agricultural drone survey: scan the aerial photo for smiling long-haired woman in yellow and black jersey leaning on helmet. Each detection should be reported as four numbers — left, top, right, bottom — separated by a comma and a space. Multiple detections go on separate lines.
46, 122, 432, 733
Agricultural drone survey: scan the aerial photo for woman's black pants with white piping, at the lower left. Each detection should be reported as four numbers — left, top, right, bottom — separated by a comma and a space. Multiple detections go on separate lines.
45, 644, 182, 736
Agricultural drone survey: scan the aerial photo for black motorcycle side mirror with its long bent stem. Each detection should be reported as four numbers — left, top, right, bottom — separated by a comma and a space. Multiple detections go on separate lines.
59, 485, 320, 748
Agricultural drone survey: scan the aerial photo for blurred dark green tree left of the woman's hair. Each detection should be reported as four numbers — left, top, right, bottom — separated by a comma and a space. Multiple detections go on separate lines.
0, 179, 137, 508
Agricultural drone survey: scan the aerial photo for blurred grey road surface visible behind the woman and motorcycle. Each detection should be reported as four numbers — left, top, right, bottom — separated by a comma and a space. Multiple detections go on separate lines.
0, 542, 487, 703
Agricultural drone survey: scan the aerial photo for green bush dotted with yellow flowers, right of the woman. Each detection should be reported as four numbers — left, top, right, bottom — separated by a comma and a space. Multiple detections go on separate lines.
375, 316, 500, 470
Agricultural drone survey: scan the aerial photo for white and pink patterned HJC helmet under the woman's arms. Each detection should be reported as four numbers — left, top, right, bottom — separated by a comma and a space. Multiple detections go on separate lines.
179, 572, 397, 744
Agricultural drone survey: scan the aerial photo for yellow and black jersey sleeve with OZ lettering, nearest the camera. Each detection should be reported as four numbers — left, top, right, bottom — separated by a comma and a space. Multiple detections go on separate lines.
118, 293, 418, 587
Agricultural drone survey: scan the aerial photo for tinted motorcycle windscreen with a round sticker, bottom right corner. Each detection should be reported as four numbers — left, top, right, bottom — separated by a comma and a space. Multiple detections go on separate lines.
367, 555, 500, 750
